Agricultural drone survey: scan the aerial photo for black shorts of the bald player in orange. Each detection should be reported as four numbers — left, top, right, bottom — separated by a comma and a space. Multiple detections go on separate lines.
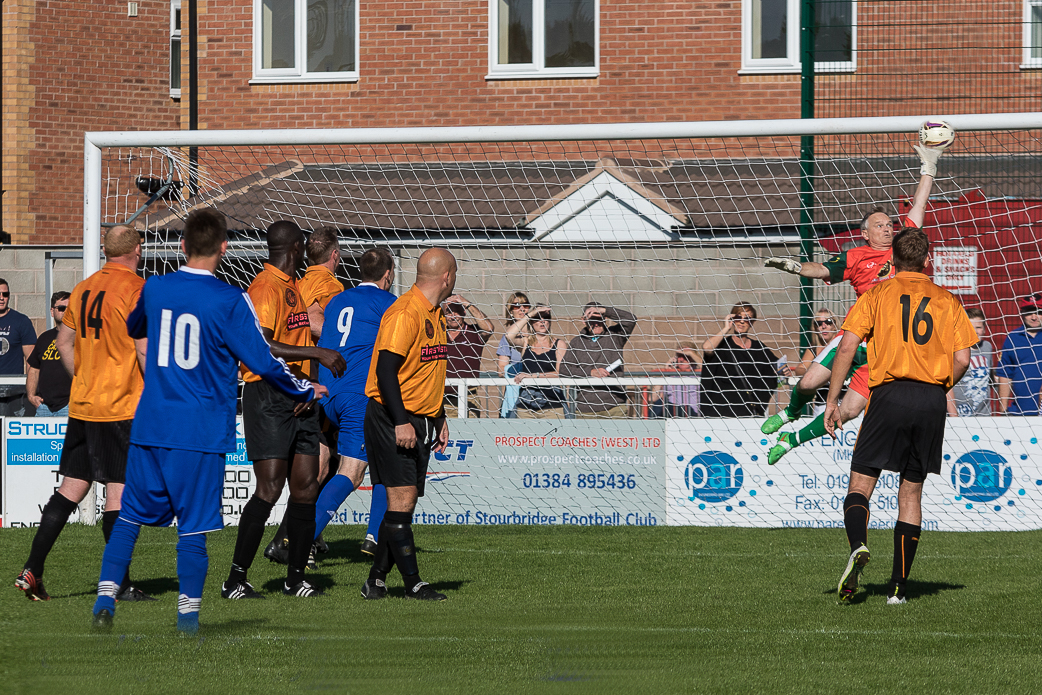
365, 398, 437, 497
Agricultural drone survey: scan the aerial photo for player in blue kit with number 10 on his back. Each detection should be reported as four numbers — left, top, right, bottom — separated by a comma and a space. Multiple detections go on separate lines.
94, 208, 327, 634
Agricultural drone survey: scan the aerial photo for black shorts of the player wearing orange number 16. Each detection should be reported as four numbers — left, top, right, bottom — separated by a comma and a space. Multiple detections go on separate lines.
850, 381, 947, 482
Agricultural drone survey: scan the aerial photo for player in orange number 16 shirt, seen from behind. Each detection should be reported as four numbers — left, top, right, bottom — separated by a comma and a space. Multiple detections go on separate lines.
824, 229, 978, 604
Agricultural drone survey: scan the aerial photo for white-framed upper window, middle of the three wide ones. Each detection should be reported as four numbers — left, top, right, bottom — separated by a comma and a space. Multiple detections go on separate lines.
488, 0, 600, 79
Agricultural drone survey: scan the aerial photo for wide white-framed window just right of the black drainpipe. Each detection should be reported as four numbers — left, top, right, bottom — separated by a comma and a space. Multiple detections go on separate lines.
251, 0, 358, 83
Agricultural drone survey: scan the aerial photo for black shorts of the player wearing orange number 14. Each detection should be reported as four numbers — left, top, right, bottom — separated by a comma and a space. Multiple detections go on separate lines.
58, 418, 133, 482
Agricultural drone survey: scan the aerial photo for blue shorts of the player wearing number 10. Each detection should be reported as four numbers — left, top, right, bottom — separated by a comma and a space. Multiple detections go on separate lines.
120, 444, 224, 536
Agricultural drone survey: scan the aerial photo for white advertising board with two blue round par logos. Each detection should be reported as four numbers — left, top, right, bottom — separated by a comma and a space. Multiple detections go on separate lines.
666, 418, 1042, 531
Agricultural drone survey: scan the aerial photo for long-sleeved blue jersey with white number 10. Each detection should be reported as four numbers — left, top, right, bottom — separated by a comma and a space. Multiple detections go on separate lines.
127, 268, 312, 453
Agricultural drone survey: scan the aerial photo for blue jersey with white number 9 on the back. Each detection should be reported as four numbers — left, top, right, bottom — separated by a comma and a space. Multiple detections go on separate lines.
319, 282, 395, 398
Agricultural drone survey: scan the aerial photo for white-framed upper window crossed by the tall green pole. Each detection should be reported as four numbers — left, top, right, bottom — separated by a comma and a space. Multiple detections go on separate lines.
742, 0, 854, 73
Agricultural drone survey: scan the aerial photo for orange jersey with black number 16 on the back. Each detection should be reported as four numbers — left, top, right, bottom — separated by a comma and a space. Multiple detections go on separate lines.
843, 272, 979, 389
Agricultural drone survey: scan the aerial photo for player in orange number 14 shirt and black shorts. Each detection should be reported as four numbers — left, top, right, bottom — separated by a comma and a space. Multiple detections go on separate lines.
15, 226, 154, 601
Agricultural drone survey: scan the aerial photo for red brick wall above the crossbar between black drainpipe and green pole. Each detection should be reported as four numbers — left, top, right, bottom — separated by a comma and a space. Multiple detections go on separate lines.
193, 0, 799, 128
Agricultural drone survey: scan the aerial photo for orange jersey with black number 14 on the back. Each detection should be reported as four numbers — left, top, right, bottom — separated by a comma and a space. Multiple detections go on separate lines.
61, 263, 145, 422
